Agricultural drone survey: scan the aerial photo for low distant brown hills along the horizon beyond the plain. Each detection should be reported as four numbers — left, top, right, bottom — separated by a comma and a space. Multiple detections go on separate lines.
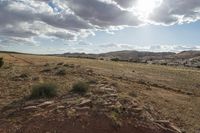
59, 50, 200, 68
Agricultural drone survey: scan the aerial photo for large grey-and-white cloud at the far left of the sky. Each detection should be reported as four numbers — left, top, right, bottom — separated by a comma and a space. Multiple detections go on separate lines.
0, 0, 92, 40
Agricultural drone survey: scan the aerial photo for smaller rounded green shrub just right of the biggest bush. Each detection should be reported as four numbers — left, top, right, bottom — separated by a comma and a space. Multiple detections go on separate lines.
71, 81, 89, 94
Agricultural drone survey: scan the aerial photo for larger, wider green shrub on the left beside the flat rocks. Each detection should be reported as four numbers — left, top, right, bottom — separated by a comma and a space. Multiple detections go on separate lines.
30, 83, 57, 99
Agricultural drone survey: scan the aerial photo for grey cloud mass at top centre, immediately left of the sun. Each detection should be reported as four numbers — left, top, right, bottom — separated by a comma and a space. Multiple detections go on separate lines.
66, 0, 142, 28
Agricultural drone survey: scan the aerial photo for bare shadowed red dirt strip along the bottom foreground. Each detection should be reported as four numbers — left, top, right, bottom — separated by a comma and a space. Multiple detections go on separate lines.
0, 115, 173, 133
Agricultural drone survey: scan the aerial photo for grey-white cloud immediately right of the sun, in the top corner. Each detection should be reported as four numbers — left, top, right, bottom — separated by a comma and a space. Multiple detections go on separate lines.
148, 0, 200, 25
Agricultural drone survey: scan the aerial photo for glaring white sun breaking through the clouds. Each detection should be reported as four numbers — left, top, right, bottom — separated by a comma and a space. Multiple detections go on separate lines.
135, 0, 162, 18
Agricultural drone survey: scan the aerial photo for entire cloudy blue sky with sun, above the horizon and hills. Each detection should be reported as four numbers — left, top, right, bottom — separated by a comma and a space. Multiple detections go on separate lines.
0, 0, 200, 54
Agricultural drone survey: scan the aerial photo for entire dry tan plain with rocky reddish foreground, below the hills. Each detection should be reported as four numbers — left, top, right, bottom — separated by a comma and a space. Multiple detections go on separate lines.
0, 52, 200, 133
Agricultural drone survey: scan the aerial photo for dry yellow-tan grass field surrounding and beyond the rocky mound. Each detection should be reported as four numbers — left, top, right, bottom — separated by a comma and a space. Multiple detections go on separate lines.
0, 53, 200, 132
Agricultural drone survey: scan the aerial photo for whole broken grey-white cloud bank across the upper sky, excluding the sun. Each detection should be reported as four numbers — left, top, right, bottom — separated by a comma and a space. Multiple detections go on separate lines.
0, 0, 200, 48
